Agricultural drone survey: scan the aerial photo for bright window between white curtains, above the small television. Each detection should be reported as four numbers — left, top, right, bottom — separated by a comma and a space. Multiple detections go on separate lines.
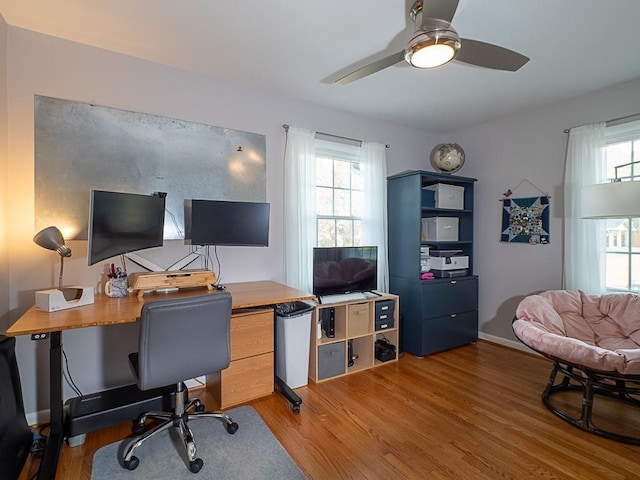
315, 140, 364, 247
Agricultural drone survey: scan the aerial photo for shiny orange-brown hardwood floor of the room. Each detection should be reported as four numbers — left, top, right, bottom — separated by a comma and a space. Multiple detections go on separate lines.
20, 341, 640, 480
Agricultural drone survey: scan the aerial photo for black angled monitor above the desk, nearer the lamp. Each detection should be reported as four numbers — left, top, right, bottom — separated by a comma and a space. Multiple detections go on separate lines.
87, 190, 165, 265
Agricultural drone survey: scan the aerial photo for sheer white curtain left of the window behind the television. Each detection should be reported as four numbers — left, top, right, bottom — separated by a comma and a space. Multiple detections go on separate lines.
284, 126, 316, 292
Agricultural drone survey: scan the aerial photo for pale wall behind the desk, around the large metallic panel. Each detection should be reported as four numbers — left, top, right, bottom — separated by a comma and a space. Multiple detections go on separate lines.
0, 27, 438, 413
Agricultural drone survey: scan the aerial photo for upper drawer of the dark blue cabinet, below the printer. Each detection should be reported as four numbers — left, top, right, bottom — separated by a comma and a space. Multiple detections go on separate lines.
421, 277, 478, 318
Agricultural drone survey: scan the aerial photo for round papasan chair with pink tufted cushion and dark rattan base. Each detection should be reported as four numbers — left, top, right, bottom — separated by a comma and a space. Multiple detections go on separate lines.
512, 290, 640, 445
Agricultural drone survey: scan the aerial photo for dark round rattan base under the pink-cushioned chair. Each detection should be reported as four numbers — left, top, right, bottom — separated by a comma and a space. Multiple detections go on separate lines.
542, 359, 640, 445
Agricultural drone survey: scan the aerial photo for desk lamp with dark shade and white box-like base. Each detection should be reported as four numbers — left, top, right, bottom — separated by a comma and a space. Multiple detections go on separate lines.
33, 227, 94, 312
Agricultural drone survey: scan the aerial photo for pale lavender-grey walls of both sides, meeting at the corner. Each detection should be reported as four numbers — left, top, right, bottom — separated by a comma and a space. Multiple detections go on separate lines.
10, 21, 640, 418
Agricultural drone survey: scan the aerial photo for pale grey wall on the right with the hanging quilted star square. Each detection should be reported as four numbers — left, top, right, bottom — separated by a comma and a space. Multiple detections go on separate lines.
456, 79, 640, 341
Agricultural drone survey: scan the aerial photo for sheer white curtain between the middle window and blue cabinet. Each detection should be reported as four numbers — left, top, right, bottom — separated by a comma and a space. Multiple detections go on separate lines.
360, 141, 389, 292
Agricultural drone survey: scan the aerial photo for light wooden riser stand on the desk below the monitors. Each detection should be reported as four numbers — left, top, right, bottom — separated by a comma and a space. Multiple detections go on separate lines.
129, 270, 217, 298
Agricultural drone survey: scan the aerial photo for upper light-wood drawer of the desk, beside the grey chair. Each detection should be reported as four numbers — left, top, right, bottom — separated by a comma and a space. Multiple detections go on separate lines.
231, 310, 274, 360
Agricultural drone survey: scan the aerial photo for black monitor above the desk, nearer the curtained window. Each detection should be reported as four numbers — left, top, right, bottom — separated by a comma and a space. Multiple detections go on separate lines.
184, 199, 269, 247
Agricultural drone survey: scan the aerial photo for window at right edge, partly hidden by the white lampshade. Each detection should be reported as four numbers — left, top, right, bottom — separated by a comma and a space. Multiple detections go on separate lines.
605, 126, 640, 291
